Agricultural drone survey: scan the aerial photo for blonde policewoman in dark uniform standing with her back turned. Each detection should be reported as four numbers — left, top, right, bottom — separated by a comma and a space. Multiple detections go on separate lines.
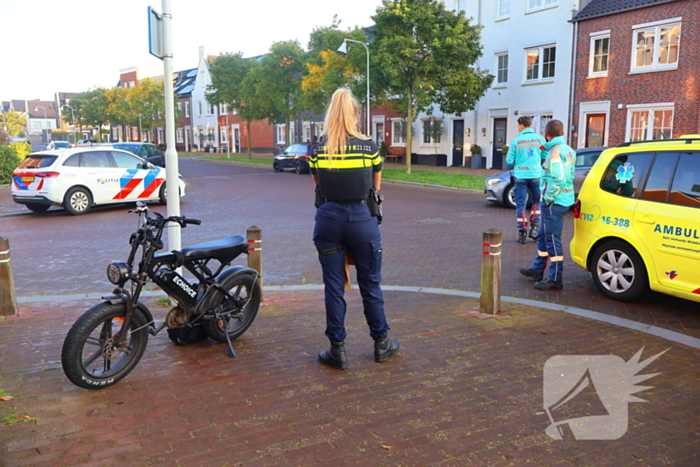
309, 88, 399, 369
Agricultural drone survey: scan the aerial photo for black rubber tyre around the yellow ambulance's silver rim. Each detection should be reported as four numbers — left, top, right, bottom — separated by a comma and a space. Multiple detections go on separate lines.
589, 240, 649, 302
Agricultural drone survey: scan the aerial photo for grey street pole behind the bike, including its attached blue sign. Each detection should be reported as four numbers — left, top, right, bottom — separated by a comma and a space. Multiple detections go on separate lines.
148, 0, 182, 251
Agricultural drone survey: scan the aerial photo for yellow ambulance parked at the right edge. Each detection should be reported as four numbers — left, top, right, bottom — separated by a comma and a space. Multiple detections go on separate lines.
570, 135, 700, 302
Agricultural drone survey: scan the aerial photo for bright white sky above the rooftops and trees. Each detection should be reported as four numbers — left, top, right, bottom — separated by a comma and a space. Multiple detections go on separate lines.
0, 0, 381, 101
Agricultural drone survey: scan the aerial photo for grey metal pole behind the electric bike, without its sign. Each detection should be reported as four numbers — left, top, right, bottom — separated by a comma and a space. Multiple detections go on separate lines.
162, 0, 182, 251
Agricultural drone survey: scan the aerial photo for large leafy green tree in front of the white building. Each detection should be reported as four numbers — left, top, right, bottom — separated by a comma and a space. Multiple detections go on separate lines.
370, 0, 493, 173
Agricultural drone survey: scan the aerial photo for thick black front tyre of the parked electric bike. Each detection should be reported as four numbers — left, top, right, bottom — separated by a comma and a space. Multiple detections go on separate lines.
61, 302, 148, 389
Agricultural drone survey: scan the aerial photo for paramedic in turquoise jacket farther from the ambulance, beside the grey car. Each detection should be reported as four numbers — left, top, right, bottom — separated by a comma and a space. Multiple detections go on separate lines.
506, 116, 545, 243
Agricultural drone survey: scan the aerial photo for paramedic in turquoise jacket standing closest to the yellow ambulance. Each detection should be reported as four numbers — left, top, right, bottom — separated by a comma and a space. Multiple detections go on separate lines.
520, 120, 576, 290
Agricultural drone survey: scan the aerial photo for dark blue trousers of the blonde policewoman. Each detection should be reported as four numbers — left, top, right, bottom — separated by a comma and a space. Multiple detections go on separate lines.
314, 201, 389, 342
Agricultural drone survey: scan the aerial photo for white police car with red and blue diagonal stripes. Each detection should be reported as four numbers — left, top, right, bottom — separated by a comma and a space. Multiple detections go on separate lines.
11, 146, 185, 215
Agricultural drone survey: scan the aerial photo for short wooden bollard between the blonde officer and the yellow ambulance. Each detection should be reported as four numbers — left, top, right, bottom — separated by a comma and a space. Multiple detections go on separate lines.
479, 229, 503, 315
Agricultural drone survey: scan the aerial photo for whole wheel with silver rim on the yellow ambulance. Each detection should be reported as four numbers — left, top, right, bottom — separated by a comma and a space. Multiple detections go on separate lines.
590, 240, 649, 302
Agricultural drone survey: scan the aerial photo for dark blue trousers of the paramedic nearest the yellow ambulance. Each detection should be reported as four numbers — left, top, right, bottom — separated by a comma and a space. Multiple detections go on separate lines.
531, 203, 569, 282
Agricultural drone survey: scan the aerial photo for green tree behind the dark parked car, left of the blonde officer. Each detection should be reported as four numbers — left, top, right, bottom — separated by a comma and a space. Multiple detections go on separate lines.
250, 41, 304, 145
